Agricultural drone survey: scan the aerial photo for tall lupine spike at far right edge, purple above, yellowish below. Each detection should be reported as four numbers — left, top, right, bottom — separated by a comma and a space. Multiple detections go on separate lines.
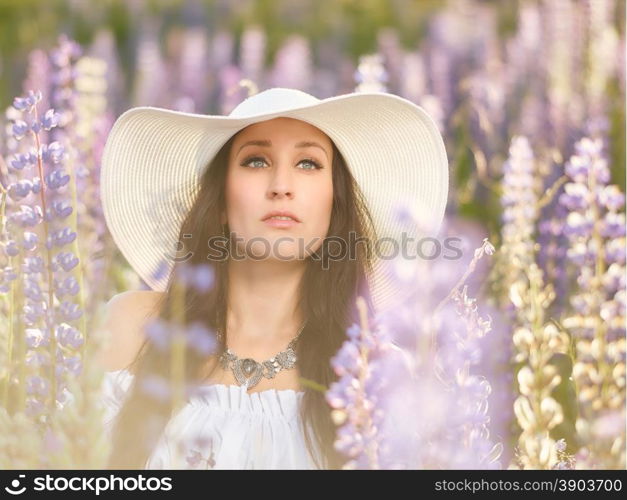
560, 133, 625, 464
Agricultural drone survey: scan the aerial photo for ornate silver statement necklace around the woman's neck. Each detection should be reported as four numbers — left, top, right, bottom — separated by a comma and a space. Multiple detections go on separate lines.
216, 321, 307, 389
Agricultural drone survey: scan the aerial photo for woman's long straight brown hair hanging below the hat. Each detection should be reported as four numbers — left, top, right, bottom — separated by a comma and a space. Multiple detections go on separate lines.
108, 128, 376, 469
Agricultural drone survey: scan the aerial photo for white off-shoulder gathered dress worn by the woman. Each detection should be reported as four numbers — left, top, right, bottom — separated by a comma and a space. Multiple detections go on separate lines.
101, 370, 319, 469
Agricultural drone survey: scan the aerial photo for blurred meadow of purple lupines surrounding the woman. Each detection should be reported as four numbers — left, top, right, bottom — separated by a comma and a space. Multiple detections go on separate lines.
0, 0, 625, 469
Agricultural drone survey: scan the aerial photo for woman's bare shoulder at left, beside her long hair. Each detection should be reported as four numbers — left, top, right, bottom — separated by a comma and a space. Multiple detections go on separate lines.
94, 290, 165, 371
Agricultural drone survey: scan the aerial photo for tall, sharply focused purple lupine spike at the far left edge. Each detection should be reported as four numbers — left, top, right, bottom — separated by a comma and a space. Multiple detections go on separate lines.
0, 75, 87, 418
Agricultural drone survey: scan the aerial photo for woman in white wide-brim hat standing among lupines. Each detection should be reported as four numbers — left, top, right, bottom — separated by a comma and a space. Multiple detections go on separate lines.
101, 88, 448, 468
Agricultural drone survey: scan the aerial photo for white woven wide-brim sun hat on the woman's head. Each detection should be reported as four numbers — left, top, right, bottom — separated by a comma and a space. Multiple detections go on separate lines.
100, 88, 449, 311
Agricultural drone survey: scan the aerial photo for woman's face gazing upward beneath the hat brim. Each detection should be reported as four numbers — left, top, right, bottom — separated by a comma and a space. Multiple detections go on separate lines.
223, 117, 333, 260
